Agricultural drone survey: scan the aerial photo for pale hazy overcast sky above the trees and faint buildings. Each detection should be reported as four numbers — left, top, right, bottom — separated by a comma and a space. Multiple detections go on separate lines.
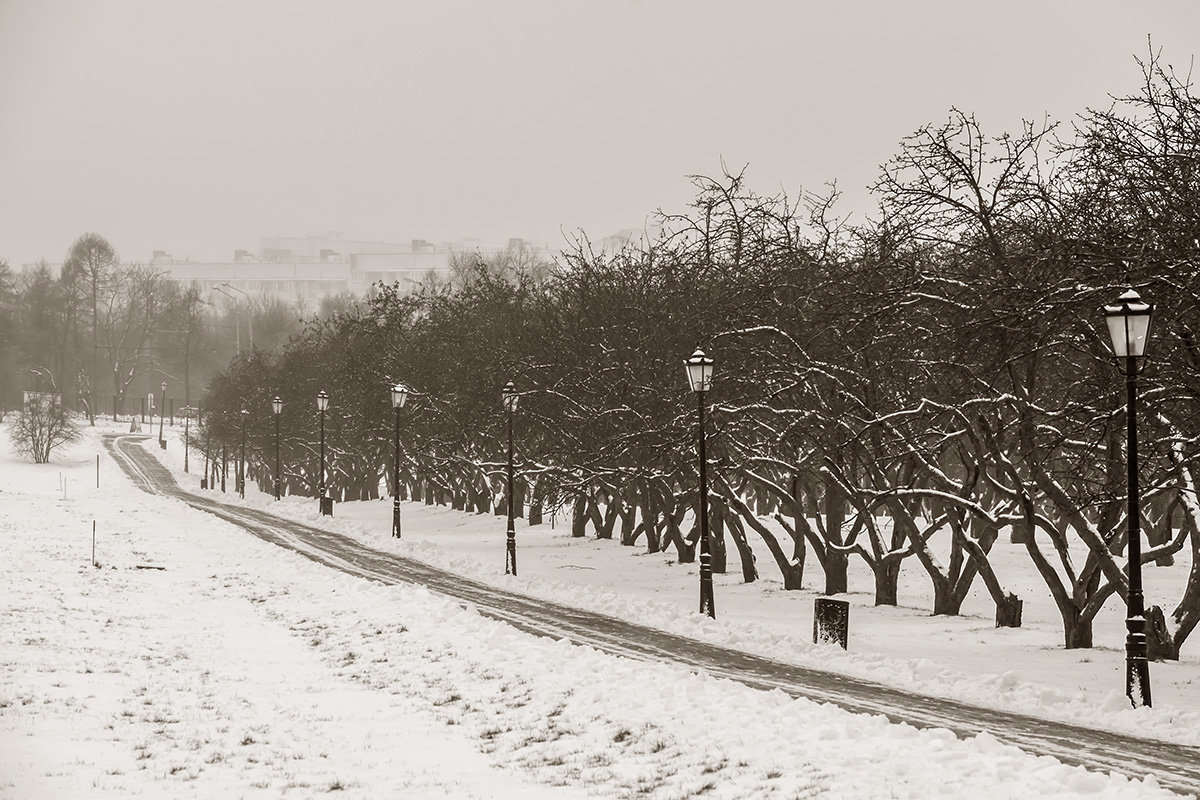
0, 0, 1200, 264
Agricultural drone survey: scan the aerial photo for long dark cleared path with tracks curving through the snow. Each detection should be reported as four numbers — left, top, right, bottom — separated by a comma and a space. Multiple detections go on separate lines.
106, 437, 1200, 793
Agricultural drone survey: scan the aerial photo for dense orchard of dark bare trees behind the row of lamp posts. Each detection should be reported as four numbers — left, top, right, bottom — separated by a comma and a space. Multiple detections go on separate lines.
198, 59, 1200, 657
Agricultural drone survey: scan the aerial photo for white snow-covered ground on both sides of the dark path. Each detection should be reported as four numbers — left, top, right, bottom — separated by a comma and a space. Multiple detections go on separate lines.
0, 427, 1200, 799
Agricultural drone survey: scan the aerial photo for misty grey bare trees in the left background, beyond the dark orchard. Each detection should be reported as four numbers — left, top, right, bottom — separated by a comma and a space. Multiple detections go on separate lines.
0, 233, 309, 420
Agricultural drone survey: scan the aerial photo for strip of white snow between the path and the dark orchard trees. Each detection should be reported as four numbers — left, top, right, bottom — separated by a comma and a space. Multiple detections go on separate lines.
157, 424, 1200, 745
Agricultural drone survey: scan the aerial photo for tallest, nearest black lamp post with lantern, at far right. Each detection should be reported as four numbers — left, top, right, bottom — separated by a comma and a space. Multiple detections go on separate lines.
1104, 289, 1154, 708
